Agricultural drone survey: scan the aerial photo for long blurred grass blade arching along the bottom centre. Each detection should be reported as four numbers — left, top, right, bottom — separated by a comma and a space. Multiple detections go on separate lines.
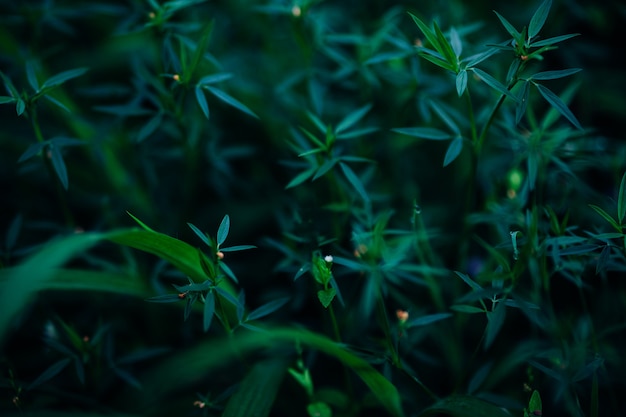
135, 327, 404, 417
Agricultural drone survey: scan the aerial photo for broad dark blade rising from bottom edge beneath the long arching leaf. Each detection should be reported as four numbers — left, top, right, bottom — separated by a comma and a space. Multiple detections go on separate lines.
222, 358, 287, 417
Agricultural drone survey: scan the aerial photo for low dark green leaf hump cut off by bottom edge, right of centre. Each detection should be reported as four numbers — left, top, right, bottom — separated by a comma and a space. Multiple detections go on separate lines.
417, 395, 511, 417
